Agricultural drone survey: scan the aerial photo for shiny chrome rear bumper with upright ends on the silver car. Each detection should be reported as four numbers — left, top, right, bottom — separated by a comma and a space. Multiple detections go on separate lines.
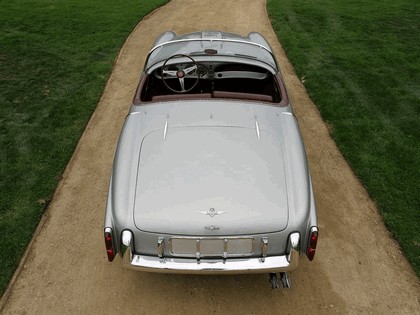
122, 231, 300, 274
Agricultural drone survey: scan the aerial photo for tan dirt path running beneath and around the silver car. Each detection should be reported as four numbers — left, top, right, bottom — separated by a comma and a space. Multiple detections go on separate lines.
0, 0, 420, 314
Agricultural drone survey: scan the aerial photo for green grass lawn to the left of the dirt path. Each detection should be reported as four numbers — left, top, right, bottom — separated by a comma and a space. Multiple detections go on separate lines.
0, 0, 167, 293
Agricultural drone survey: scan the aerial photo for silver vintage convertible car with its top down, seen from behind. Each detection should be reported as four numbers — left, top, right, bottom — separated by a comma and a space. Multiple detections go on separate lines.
104, 31, 318, 288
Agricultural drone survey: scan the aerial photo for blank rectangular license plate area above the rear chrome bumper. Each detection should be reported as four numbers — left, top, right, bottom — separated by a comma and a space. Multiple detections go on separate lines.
169, 237, 255, 258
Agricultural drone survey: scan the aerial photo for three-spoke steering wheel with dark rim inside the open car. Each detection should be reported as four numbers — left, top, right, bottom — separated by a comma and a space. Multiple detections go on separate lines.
162, 54, 200, 93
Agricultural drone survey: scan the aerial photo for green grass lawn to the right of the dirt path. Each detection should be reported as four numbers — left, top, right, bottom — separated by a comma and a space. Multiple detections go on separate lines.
268, 0, 420, 276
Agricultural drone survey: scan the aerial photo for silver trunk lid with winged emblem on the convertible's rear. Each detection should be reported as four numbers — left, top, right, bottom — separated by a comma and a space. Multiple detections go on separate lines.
133, 126, 289, 236
